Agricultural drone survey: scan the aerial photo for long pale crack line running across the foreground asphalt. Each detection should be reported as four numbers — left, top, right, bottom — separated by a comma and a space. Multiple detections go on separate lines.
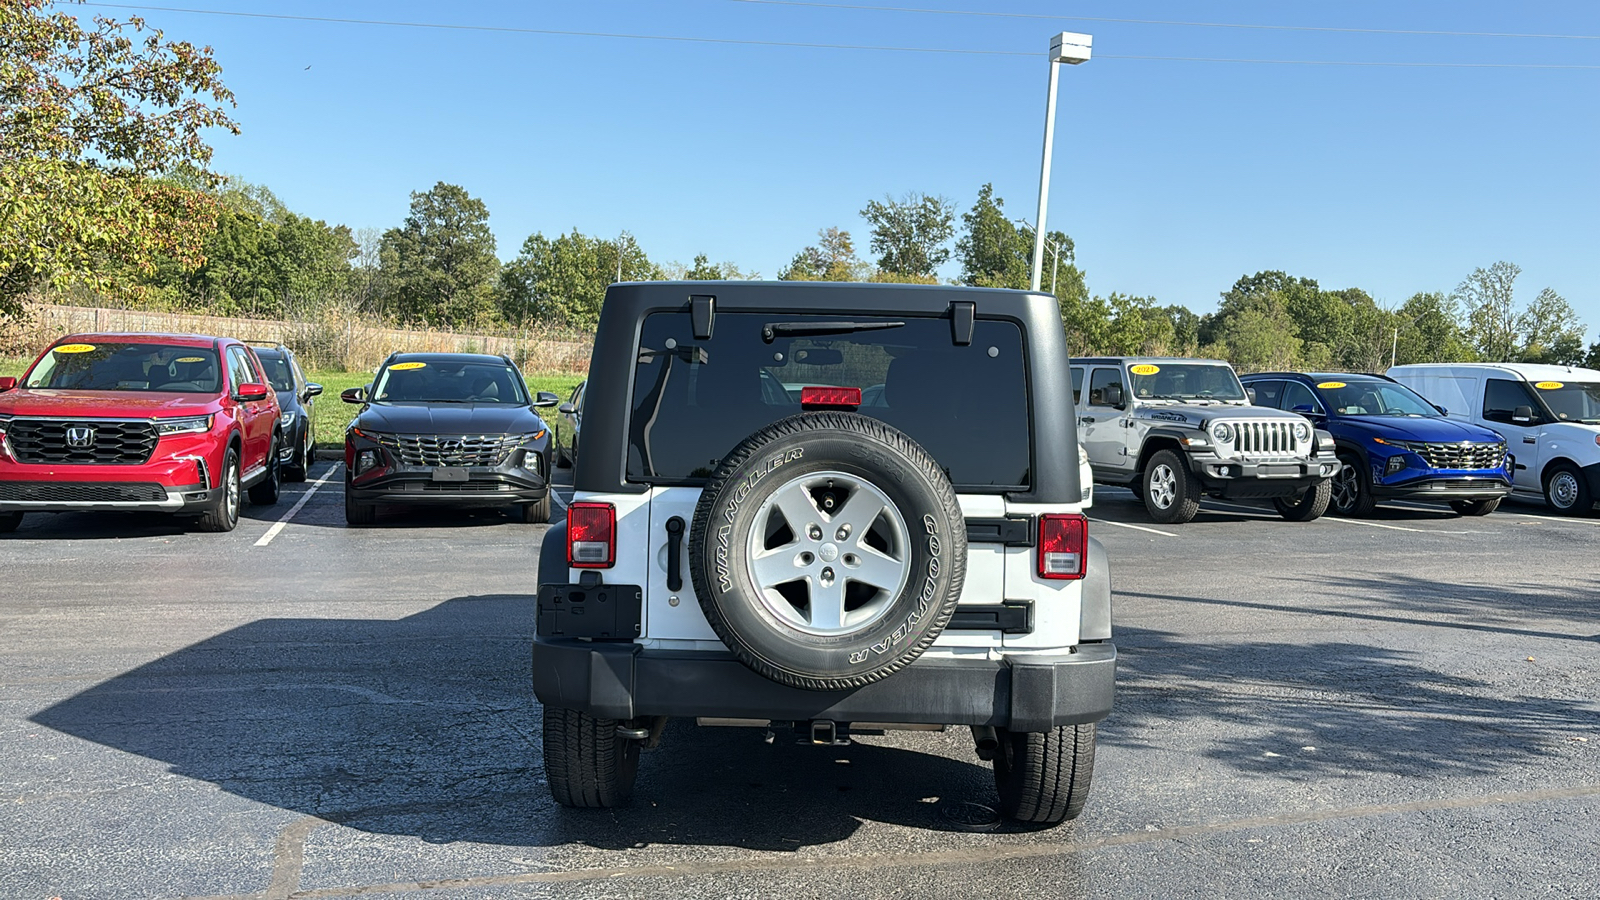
196, 785, 1600, 900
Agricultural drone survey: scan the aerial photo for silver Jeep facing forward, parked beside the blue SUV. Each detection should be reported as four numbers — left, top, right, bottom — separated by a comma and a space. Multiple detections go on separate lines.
1072, 357, 1339, 524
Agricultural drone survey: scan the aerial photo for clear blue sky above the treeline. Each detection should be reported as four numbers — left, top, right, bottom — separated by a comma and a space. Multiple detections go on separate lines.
72, 0, 1600, 329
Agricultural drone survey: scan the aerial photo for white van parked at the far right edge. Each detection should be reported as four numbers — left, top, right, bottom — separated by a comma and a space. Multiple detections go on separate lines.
1389, 362, 1600, 516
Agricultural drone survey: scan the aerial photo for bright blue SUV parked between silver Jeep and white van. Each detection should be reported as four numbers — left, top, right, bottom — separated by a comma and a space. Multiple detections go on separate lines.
1240, 372, 1512, 516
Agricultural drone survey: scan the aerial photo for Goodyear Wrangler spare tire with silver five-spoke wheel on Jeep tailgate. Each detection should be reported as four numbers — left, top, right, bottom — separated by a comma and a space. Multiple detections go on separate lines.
690, 413, 966, 690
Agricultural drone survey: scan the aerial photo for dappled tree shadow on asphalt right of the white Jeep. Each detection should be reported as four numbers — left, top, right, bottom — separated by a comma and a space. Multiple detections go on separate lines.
1101, 614, 1600, 781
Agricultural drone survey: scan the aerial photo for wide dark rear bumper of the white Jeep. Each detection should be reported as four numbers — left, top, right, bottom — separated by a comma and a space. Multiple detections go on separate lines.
533, 637, 1117, 732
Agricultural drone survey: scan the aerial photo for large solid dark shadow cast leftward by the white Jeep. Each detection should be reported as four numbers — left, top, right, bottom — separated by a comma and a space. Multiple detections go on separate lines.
32, 596, 995, 850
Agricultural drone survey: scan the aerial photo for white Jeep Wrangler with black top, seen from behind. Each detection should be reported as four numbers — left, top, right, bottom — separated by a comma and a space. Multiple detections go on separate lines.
533, 282, 1117, 823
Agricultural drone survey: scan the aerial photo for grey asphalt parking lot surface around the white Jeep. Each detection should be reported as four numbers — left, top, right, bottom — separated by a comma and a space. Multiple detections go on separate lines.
0, 463, 1600, 900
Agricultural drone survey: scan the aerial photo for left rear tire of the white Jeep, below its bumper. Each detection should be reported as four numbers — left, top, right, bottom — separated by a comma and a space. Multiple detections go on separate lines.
544, 706, 638, 809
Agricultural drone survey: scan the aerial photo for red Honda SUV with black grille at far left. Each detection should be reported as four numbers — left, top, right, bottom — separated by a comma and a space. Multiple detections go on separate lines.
0, 335, 282, 532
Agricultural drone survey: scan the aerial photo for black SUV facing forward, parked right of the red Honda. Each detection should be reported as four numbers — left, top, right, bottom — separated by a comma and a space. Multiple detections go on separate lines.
339, 347, 560, 525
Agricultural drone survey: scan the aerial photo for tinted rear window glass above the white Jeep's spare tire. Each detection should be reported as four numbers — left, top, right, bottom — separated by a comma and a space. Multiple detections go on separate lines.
627, 312, 1032, 490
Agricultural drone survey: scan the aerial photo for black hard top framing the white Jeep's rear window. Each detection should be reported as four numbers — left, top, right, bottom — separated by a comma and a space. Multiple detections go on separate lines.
573, 282, 1082, 503
